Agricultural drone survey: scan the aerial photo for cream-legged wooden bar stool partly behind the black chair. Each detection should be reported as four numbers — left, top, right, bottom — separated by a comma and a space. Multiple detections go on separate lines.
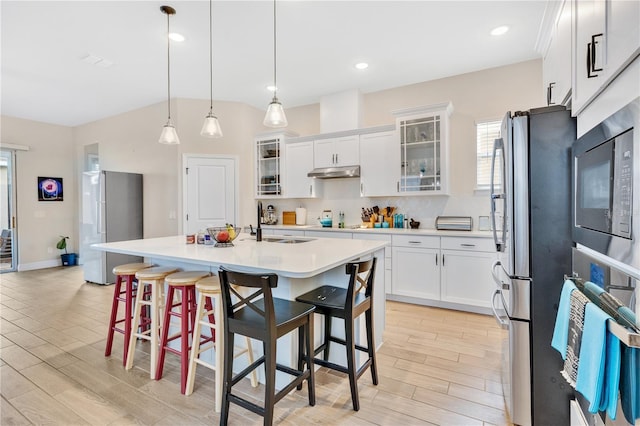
185, 276, 258, 413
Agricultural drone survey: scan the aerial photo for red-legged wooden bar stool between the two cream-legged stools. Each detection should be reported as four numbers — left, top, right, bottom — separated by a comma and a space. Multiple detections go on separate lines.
156, 271, 210, 394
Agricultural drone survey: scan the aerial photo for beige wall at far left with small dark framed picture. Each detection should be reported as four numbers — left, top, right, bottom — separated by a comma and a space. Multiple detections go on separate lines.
1, 116, 79, 268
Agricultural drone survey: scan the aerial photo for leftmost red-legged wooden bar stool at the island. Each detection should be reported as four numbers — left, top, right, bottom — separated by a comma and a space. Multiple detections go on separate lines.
104, 263, 153, 365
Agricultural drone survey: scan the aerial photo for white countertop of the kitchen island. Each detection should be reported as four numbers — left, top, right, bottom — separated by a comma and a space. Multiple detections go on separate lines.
91, 233, 387, 278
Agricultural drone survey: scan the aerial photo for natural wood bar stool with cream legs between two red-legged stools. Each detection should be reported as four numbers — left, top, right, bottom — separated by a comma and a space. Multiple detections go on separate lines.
125, 266, 178, 379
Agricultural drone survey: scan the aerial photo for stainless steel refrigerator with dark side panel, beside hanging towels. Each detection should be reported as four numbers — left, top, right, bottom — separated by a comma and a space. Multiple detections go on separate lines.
491, 106, 576, 425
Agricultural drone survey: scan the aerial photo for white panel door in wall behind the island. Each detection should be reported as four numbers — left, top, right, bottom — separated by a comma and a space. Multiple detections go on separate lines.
183, 155, 237, 234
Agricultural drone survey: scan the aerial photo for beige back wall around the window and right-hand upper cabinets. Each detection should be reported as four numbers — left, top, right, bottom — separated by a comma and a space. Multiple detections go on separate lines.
272, 60, 545, 228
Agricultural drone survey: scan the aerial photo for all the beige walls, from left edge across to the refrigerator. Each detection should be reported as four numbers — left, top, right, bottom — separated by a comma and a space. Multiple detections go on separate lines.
2, 60, 544, 270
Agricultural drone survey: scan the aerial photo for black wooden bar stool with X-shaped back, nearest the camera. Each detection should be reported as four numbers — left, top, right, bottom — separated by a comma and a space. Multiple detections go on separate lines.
219, 268, 316, 425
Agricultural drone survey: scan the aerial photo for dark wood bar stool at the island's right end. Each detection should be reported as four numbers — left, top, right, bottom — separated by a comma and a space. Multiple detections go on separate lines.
296, 258, 378, 411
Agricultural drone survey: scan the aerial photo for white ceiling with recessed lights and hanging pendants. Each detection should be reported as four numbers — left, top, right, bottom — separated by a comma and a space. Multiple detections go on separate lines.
0, 0, 547, 126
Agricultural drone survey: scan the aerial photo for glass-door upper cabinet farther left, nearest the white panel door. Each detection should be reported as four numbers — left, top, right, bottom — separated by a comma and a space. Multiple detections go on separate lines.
255, 132, 295, 198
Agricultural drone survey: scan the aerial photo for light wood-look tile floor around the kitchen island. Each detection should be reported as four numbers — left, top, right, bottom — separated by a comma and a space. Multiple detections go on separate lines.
0, 267, 510, 426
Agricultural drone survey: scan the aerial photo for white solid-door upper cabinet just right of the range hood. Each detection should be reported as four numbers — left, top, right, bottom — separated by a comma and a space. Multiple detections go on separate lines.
360, 131, 400, 197
